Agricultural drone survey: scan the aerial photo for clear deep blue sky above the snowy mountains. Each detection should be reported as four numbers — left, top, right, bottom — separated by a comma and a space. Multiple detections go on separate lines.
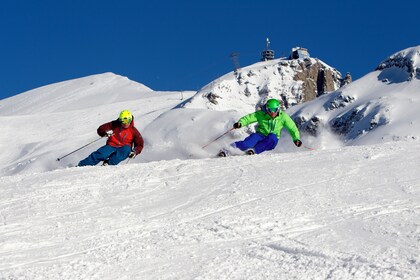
0, 0, 420, 99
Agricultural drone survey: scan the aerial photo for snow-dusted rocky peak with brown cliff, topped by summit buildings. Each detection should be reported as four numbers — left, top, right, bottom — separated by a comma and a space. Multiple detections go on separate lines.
184, 49, 351, 111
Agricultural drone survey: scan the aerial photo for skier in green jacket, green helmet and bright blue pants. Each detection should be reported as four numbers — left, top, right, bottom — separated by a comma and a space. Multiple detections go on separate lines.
219, 99, 302, 157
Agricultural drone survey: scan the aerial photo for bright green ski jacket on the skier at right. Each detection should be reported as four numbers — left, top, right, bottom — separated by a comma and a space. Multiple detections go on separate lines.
239, 110, 300, 141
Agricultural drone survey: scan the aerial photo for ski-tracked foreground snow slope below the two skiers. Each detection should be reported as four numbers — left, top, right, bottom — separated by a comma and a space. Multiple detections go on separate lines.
0, 142, 420, 279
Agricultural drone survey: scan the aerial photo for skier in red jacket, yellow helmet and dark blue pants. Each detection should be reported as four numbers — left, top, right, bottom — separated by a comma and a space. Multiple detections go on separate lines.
78, 110, 144, 166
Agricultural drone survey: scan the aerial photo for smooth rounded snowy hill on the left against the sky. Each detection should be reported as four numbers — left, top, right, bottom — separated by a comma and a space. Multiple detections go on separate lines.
0, 73, 152, 116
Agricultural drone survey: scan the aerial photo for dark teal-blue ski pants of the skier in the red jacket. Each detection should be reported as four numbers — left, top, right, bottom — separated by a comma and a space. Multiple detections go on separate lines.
78, 145, 131, 166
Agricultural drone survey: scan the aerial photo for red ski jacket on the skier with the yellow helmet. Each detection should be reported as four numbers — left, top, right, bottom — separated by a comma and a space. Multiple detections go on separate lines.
97, 118, 144, 155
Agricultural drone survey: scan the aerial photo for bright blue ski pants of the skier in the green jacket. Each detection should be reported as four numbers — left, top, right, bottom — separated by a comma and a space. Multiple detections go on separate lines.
235, 133, 279, 154
